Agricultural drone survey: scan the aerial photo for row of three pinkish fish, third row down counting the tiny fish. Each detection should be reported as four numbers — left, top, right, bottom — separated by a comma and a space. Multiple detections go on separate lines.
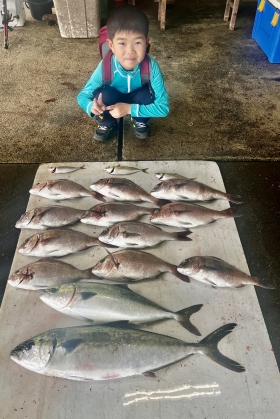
16, 202, 241, 230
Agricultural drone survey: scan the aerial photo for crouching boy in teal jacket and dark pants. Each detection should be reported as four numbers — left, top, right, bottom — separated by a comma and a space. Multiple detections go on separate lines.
77, 5, 169, 141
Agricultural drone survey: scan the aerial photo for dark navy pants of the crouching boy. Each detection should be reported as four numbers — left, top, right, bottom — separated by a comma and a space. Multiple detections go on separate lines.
93, 84, 154, 127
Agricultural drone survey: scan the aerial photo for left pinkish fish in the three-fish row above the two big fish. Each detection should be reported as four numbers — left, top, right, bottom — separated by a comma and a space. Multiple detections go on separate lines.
8, 258, 96, 290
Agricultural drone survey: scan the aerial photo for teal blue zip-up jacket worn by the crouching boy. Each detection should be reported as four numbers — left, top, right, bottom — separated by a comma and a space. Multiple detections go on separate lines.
77, 54, 169, 118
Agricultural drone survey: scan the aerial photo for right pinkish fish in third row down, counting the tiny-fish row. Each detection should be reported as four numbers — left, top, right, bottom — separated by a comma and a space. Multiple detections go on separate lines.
150, 202, 241, 228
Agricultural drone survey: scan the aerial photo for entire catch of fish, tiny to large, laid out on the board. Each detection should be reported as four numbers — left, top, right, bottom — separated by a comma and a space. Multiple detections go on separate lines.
8, 165, 264, 380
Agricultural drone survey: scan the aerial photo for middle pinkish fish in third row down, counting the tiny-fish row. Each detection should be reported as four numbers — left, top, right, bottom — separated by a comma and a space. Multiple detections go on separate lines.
80, 202, 155, 227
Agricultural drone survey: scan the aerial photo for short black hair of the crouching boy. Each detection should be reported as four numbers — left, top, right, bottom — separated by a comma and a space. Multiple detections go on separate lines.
107, 4, 149, 41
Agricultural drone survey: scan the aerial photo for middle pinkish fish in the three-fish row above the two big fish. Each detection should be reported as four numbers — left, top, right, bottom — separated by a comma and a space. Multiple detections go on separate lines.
92, 250, 189, 282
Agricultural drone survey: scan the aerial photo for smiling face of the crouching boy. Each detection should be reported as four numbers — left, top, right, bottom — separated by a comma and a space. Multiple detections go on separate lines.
107, 32, 149, 70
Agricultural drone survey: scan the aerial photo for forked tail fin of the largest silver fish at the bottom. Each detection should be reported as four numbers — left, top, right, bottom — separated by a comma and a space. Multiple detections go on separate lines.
198, 323, 245, 372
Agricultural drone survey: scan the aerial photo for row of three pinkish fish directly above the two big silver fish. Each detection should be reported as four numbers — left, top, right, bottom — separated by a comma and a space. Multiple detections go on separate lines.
8, 250, 274, 290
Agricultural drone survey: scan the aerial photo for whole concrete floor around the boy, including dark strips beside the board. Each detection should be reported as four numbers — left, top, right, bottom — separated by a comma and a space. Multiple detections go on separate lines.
0, 0, 280, 378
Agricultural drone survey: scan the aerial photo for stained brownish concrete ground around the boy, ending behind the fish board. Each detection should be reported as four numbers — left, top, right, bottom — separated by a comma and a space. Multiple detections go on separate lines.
0, 0, 280, 163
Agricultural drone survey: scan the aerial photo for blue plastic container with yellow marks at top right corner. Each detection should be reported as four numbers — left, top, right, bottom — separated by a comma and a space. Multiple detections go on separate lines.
252, 0, 280, 64
